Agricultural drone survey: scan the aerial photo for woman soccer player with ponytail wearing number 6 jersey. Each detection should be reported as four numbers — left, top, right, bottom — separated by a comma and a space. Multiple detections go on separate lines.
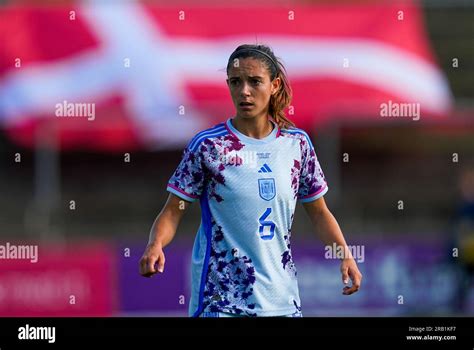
140, 45, 362, 317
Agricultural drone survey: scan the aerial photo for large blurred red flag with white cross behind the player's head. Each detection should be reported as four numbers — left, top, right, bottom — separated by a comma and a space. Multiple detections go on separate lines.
0, 1, 452, 151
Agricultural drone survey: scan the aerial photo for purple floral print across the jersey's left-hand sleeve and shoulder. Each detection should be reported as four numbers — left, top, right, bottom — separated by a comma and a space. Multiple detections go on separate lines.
169, 134, 244, 202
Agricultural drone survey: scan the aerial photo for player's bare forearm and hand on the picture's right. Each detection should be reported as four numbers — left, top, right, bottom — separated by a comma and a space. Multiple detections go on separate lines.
303, 197, 362, 295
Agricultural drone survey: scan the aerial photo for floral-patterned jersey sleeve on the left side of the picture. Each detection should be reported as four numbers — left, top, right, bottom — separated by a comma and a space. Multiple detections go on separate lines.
166, 145, 204, 202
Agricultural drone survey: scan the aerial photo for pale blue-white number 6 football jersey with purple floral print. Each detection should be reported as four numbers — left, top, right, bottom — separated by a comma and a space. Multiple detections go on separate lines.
167, 119, 328, 316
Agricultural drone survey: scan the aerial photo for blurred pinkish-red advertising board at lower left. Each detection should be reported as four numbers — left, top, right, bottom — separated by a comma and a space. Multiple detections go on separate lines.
0, 242, 117, 317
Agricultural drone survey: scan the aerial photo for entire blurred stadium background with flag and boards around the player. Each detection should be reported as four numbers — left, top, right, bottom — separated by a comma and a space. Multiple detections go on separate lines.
0, 0, 474, 316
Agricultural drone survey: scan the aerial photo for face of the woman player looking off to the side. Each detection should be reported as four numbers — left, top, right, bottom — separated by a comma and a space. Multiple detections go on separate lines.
226, 57, 280, 119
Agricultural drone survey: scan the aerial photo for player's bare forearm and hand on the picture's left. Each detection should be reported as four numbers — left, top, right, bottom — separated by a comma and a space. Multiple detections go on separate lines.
140, 193, 190, 277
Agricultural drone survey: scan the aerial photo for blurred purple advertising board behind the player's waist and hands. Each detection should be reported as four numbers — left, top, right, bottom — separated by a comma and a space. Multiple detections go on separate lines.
118, 237, 474, 316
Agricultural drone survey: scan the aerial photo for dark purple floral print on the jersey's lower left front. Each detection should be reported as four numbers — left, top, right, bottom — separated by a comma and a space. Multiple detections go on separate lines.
204, 220, 256, 316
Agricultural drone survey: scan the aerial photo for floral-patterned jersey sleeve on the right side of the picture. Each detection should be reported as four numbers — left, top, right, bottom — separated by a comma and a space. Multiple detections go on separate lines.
298, 135, 328, 203
